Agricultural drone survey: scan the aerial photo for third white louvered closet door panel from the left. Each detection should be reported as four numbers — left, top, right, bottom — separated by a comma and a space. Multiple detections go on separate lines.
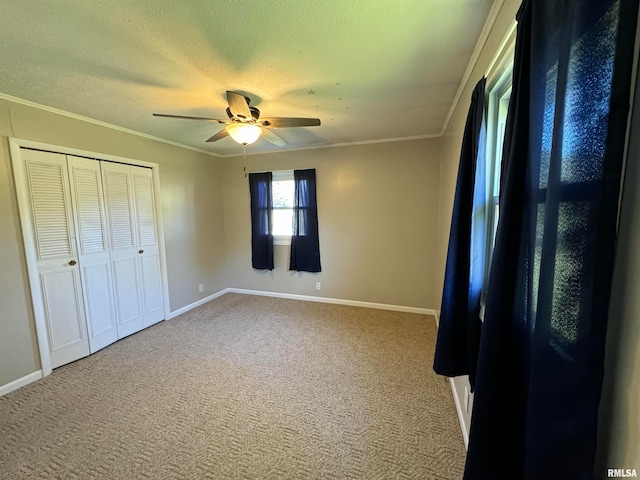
100, 162, 144, 338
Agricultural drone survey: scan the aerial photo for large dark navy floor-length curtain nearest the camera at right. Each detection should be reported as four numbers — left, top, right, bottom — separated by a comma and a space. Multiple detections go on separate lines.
464, 0, 638, 480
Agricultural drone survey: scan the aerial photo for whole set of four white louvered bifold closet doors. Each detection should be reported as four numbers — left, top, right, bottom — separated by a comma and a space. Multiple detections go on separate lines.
17, 148, 164, 368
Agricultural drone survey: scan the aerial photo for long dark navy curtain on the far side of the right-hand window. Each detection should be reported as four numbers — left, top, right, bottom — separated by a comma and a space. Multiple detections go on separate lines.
433, 78, 486, 388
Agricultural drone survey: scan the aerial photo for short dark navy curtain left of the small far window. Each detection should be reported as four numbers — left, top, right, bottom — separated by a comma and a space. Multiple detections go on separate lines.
249, 172, 273, 270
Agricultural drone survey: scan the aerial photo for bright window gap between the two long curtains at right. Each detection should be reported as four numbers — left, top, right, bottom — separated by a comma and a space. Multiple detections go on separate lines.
480, 64, 513, 318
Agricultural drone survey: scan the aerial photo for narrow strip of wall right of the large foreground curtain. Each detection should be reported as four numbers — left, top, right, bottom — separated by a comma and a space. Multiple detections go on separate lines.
596, 66, 640, 472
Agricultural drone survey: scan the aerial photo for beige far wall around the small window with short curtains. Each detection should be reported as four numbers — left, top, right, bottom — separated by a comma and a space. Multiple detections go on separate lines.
224, 139, 440, 309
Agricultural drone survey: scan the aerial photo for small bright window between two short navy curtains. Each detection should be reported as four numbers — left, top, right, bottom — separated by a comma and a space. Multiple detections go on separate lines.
271, 170, 295, 245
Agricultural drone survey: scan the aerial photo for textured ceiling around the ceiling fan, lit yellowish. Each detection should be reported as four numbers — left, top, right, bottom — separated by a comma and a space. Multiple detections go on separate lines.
0, 0, 493, 155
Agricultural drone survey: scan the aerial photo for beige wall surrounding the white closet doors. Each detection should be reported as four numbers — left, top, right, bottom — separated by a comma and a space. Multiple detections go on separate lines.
0, 100, 226, 385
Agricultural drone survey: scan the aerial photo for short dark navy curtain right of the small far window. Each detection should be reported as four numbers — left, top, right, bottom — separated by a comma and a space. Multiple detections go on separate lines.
289, 168, 321, 272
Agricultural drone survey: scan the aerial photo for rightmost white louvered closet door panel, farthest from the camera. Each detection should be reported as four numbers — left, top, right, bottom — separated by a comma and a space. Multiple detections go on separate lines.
131, 166, 164, 327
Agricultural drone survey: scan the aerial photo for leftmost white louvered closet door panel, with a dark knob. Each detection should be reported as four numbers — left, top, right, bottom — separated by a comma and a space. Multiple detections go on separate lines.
21, 149, 90, 368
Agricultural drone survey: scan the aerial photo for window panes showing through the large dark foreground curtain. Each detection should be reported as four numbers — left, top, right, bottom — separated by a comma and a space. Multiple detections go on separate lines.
529, 9, 622, 361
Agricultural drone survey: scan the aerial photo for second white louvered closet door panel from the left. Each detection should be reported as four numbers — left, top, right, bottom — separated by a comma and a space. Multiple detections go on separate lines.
67, 156, 118, 353
